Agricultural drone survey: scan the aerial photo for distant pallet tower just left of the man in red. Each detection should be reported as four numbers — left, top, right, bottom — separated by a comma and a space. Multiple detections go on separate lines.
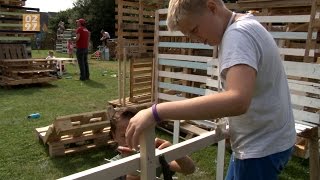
56, 29, 76, 53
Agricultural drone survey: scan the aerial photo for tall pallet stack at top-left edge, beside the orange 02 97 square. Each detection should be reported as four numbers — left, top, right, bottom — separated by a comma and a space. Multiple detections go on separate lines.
0, 0, 40, 57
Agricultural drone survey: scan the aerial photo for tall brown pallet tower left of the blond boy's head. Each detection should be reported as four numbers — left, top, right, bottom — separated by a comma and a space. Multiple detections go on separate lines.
116, 0, 161, 59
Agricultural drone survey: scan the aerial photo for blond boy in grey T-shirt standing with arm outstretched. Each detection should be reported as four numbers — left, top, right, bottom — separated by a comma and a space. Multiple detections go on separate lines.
126, 0, 296, 180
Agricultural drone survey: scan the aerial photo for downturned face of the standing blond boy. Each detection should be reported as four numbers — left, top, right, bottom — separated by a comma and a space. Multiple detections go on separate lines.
179, 2, 226, 46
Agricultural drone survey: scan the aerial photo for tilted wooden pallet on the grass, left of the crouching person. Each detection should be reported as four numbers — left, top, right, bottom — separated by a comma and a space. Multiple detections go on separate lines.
35, 111, 112, 157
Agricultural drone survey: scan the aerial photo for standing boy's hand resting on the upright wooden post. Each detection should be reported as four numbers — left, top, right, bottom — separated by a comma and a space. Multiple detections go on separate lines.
126, 108, 156, 149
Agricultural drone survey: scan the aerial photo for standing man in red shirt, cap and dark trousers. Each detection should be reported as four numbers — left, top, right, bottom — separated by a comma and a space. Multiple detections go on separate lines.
76, 19, 90, 81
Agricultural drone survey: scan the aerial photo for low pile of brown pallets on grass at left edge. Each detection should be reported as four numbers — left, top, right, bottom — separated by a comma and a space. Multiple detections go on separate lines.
0, 44, 57, 86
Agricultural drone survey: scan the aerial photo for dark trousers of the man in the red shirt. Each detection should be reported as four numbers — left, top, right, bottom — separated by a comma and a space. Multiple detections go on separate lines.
77, 48, 90, 81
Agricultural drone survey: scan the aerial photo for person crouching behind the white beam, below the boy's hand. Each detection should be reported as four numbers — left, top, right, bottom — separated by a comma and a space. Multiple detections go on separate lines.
110, 107, 195, 180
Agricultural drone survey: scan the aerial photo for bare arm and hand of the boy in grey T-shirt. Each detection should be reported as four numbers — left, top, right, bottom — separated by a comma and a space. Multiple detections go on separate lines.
126, 64, 256, 148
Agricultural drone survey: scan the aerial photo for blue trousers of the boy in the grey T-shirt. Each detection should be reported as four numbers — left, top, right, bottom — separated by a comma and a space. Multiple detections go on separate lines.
226, 148, 293, 180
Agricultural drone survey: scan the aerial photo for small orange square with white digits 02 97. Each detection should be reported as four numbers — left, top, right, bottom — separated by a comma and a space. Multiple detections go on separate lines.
22, 14, 40, 31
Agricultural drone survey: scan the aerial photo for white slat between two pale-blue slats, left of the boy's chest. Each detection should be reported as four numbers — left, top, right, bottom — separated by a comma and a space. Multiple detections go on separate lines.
159, 71, 207, 83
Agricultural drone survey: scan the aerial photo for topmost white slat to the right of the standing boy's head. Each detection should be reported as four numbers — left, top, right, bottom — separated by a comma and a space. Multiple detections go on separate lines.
255, 15, 310, 23
